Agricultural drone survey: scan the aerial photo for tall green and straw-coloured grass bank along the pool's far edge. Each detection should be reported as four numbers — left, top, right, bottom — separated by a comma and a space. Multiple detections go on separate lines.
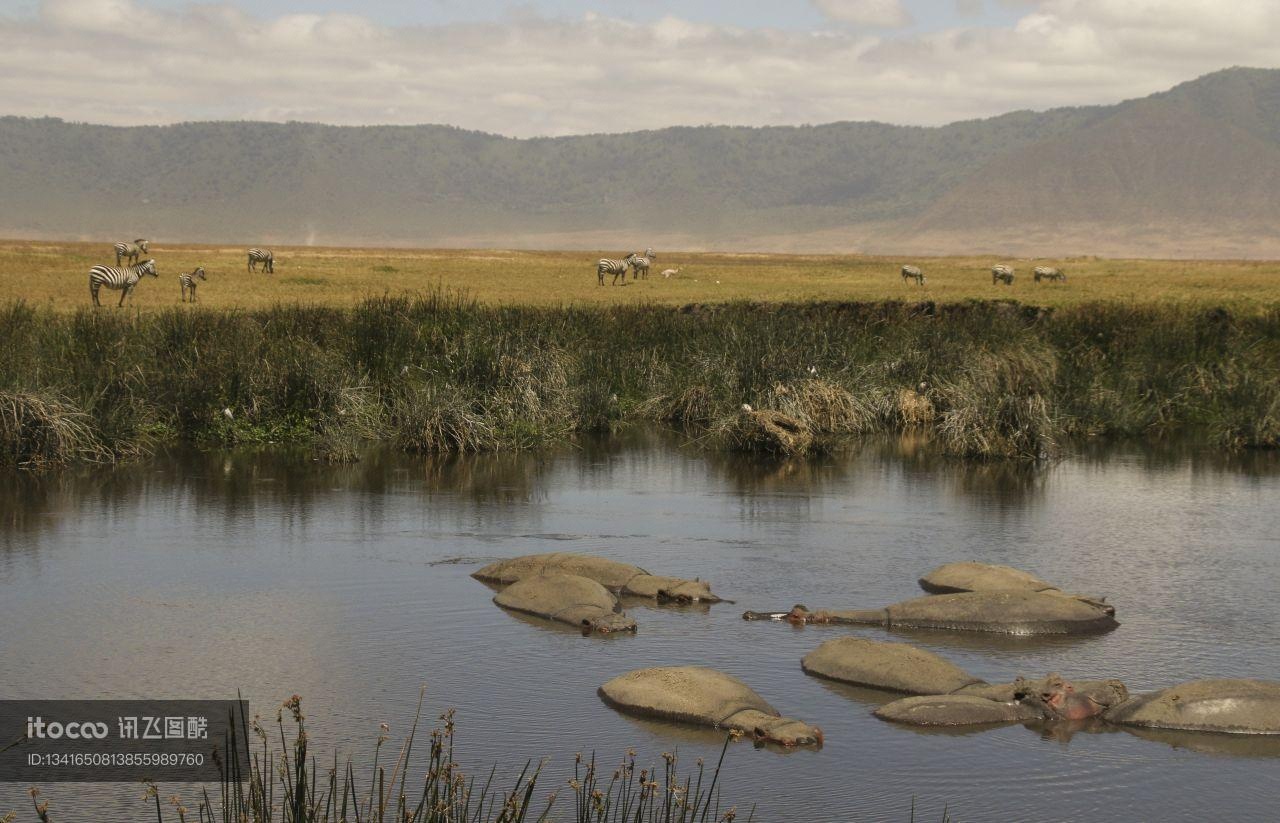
0, 292, 1280, 466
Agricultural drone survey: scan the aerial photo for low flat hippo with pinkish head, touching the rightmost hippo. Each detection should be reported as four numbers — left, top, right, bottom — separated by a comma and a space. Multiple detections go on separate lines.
874, 673, 1128, 727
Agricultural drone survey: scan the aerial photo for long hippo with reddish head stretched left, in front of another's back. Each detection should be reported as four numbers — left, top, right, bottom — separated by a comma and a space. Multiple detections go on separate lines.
742, 591, 1120, 635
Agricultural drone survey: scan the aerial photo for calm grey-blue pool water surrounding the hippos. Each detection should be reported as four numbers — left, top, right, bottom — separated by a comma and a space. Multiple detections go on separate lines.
0, 434, 1280, 822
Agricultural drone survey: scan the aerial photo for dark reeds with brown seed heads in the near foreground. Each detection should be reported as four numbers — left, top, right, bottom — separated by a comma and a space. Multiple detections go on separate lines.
10, 695, 754, 823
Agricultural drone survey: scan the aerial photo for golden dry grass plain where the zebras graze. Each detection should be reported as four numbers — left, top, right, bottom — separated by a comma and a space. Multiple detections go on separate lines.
10, 239, 1280, 316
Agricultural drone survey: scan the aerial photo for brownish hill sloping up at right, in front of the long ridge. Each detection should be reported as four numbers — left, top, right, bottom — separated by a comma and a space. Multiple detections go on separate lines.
913, 72, 1280, 248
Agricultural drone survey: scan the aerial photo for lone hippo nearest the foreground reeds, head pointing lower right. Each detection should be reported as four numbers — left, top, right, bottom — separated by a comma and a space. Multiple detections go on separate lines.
598, 666, 822, 747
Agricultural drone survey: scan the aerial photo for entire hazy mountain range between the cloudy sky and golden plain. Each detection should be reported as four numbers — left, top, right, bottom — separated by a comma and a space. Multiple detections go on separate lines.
0, 69, 1280, 256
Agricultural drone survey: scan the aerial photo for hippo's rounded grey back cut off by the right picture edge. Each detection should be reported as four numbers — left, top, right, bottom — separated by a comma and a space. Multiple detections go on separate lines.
1102, 680, 1280, 735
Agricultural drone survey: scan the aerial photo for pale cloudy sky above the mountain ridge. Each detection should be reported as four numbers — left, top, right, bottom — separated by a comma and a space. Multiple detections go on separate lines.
0, 0, 1280, 137
